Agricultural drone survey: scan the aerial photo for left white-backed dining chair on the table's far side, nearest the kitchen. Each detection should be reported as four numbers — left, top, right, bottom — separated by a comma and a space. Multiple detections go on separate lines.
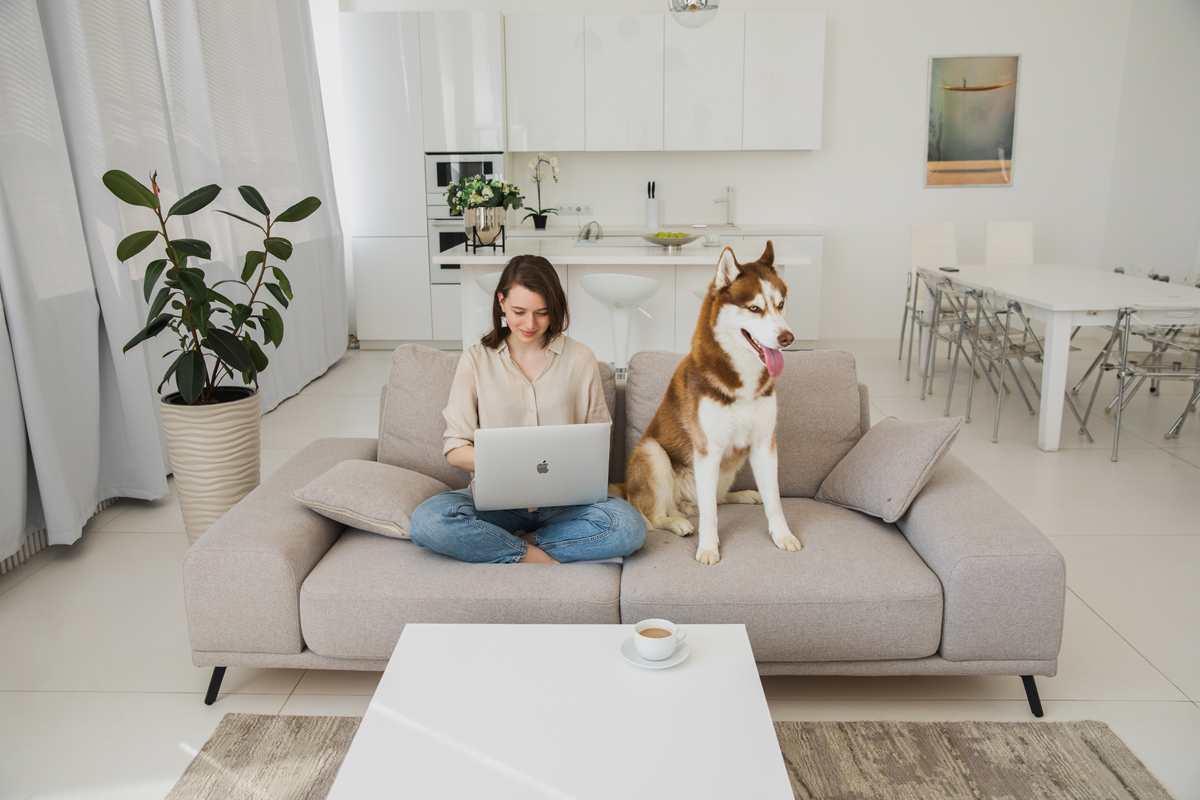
896, 222, 959, 386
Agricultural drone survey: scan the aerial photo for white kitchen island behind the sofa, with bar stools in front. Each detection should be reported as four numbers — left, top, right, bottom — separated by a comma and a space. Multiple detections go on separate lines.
433, 235, 822, 361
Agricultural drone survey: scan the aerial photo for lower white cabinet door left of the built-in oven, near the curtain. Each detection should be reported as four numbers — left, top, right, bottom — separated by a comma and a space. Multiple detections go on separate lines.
352, 236, 433, 342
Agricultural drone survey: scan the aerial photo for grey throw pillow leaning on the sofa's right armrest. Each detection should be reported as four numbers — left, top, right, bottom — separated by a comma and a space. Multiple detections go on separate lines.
816, 416, 962, 522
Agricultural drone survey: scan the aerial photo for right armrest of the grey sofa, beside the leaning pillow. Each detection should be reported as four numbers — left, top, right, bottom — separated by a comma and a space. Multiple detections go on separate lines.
896, 455, 1067, 661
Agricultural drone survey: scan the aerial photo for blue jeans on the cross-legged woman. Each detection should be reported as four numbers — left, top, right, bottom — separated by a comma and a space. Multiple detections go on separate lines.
409, 488, 646, 564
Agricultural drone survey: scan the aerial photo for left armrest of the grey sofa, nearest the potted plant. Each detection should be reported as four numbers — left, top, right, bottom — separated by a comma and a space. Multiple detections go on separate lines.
184, 439, 376, 666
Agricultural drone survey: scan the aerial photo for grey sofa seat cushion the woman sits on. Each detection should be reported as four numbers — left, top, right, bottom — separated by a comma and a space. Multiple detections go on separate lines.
300, 528, 620, 658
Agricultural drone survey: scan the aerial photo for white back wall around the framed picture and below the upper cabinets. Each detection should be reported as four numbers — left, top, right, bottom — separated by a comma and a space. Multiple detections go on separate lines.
341, 0, 1200, 338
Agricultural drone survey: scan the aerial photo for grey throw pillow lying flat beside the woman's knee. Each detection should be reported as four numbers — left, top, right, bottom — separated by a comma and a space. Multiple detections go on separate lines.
292, 461, 450, 539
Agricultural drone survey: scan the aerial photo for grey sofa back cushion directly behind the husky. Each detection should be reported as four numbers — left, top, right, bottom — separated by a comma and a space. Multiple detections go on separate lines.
625, 350, 869, 498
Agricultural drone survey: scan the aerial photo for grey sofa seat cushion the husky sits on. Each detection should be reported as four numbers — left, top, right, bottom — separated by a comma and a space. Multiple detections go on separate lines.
620, 498, 942, 662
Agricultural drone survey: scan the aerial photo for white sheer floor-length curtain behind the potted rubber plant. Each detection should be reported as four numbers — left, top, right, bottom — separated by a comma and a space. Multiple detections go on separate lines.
0, 0, 347, 559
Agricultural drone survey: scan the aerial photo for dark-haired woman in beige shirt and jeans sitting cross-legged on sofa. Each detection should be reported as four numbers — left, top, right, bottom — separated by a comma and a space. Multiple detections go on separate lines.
410, 255, 646, 564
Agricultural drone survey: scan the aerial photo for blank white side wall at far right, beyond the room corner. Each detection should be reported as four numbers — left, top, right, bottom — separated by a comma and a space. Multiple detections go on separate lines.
1103, 0, 1200, 279
